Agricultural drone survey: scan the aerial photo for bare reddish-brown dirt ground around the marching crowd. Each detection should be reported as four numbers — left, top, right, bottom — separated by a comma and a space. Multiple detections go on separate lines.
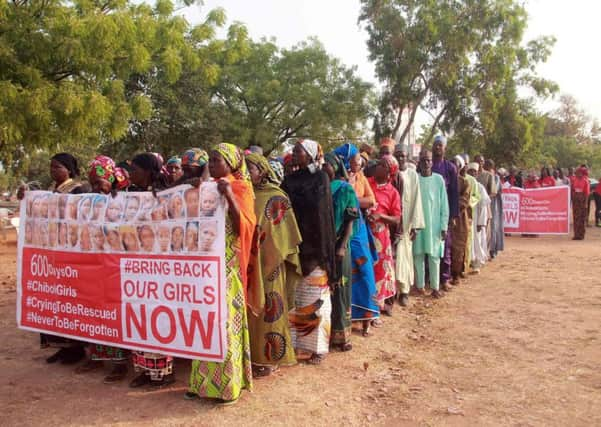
0, 228, 601, 426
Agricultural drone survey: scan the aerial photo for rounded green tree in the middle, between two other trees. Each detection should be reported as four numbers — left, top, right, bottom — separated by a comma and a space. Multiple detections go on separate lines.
213, 39, 371, 152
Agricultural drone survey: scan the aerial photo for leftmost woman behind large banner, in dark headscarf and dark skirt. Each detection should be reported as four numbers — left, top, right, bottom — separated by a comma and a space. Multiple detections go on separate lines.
40, 153, 88, 364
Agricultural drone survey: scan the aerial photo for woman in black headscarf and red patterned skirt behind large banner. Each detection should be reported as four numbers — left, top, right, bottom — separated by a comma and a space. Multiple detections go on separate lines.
129, 153, 175, 387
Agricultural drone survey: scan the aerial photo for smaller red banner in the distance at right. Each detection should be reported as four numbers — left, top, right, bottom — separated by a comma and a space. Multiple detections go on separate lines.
502, 186, 570, 234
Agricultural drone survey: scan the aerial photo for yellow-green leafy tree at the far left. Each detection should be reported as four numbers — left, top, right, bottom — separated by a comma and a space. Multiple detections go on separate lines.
0, 0, 211, 172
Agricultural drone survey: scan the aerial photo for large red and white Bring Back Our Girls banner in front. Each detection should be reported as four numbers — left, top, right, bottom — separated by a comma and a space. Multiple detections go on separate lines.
17, 182, 227, 361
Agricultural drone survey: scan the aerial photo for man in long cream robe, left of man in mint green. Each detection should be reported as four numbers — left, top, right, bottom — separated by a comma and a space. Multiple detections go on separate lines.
394, 144, 424, 307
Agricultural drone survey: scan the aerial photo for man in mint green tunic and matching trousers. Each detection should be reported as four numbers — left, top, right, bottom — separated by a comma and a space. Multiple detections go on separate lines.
413, 151, 449, 298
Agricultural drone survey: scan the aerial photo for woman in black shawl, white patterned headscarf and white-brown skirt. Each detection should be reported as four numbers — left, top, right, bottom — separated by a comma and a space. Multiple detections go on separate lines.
282, 139, 340, 364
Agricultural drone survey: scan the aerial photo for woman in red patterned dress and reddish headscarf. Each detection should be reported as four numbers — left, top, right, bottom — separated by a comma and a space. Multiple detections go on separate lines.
367, 154, 401, 325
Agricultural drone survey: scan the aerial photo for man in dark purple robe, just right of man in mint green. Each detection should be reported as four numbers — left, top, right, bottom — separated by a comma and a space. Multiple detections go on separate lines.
432, 135, 459, 291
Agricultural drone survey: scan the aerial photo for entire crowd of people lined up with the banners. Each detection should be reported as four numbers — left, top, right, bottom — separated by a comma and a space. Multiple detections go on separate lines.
19, 136, 589, 404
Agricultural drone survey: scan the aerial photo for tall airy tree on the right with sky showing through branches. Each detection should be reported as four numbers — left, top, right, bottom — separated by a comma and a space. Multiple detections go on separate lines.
360, 0, 555, 153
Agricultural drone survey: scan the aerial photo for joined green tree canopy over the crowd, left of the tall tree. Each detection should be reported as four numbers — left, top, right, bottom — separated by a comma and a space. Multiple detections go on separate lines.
0, 0, 372, 187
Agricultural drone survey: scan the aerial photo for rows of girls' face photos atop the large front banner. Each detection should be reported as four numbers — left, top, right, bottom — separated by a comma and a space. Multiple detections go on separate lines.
22, 182, 225, 254
